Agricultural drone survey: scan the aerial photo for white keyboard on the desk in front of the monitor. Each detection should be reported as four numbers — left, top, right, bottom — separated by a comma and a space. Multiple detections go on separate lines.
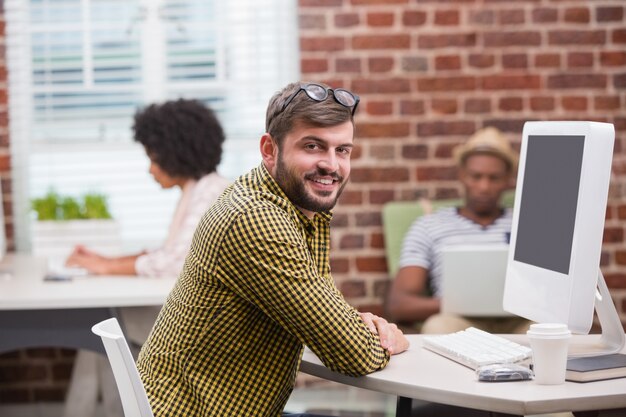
423, 327, 531, 369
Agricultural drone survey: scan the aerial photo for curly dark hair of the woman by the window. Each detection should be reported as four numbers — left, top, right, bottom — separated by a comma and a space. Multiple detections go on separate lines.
133, 99, 224, 179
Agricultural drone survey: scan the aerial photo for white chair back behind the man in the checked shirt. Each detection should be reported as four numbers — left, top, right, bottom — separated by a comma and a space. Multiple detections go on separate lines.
91, 318, 154, 417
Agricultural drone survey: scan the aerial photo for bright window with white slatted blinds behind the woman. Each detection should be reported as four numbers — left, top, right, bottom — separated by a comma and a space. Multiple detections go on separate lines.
5, 0, 299, 250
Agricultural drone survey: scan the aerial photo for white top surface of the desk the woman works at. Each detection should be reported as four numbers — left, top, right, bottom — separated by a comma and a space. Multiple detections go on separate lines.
0, 250, 175, 310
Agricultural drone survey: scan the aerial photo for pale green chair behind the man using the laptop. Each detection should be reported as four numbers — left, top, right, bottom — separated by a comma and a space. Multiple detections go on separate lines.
383, 190, 515, 278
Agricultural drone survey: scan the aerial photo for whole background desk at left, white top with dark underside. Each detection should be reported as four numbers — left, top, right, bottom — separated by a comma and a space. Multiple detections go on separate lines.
0, 254, 174, 353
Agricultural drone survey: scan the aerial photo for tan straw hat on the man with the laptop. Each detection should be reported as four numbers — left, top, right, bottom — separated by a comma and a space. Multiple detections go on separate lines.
453, 127, 518, 171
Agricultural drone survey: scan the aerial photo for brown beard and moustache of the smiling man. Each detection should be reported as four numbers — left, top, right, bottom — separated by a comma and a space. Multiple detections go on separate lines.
276, 153, 348, 213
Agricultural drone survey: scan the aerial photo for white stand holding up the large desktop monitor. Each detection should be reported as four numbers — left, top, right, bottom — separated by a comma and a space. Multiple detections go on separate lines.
568, 271, 625, 357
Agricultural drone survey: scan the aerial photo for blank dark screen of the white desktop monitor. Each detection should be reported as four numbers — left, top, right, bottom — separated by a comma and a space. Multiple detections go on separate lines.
514, 135, 585, 274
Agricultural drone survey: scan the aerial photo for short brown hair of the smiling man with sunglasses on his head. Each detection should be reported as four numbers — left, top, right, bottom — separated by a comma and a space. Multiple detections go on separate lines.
265, 81, 354, 147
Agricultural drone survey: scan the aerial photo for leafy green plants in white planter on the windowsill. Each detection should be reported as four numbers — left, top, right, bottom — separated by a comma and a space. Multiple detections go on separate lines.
31, 190, 121, 264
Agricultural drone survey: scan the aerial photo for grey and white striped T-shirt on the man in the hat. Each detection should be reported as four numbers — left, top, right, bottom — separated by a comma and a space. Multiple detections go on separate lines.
400, 207, 512, 297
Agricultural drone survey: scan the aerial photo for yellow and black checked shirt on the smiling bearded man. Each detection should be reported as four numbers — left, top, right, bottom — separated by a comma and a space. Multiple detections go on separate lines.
137, 165, 389, 417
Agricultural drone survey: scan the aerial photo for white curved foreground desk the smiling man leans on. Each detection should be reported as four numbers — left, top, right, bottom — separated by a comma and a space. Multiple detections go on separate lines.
300, 335, 626, 416
